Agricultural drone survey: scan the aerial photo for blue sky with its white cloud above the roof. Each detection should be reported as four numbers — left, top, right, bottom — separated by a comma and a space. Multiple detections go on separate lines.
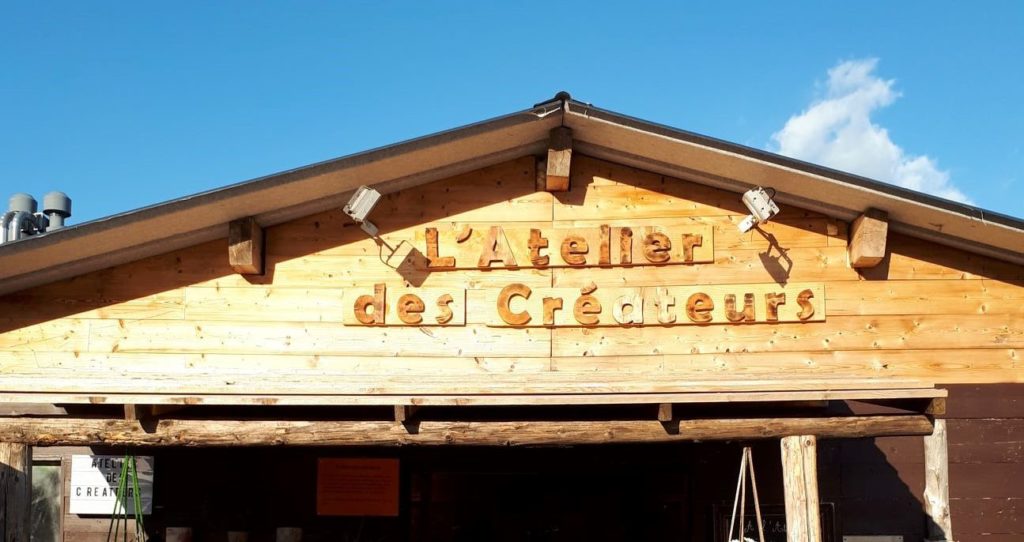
0, 1, 1024, 223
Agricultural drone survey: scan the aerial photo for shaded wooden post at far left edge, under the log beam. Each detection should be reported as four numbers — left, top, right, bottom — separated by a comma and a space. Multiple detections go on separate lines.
0, 442, 32, 542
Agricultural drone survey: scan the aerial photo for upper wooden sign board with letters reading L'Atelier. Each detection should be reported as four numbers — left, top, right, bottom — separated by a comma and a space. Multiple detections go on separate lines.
416, 223, 715, 272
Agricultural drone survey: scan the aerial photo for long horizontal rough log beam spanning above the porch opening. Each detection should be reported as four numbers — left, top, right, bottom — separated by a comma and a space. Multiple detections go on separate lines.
0, 414, 932, 447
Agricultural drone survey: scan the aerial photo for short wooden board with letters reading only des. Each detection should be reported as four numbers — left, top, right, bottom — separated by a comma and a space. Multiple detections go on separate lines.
342, 284, 468, 326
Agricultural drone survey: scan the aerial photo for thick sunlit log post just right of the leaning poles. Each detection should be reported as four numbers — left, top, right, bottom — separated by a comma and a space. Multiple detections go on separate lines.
782, 435, 821, 542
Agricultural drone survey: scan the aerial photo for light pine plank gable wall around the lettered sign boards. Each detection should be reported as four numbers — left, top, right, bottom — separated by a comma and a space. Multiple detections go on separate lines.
0, 155, 1024, 393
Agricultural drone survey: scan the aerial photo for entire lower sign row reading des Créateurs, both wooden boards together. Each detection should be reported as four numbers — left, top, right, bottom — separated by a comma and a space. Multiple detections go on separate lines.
342, 282, 825, 328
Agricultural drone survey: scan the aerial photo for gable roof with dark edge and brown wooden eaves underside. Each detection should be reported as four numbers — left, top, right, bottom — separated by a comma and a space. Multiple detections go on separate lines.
0, 93, 1024, 294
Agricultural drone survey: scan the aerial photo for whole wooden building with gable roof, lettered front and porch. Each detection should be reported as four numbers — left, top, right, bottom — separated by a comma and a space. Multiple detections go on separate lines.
0, 95, 1024, 542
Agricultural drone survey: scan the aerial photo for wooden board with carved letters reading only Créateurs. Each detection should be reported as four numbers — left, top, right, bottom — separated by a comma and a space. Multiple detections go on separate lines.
485, 284, 825, 327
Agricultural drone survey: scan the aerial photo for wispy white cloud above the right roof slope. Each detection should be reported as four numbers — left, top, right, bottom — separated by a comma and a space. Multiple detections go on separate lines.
771, 58, 971, 203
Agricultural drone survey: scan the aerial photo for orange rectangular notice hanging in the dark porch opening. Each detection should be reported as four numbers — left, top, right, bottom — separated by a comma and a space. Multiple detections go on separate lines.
316, 458, 398, 516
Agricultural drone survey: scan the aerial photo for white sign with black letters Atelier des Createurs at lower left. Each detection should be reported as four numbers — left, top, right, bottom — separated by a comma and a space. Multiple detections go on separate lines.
69, 455, 153, 515
